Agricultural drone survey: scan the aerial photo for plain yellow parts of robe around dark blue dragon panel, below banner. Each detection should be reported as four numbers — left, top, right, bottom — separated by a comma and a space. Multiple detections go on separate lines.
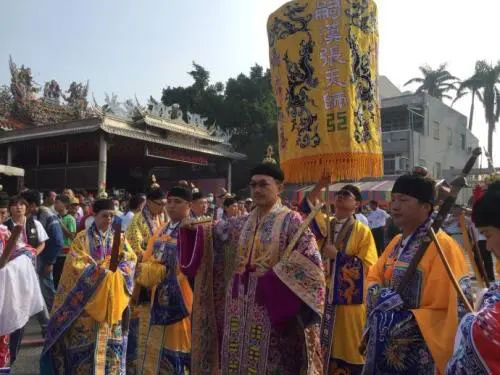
315, 213, 377, 365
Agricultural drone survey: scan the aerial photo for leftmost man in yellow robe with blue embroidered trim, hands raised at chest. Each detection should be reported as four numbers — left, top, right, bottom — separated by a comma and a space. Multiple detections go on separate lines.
41, 199, 137, 375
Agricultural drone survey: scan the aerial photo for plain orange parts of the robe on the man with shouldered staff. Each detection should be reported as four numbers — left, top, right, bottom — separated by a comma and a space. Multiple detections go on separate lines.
367, 231, 468, 374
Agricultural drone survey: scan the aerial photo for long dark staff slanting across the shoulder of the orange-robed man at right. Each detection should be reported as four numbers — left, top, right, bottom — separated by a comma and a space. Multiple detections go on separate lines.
396, 147, 481, 302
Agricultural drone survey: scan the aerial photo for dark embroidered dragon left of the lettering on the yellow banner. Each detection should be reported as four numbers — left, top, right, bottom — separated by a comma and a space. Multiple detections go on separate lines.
284, 33, 321, 148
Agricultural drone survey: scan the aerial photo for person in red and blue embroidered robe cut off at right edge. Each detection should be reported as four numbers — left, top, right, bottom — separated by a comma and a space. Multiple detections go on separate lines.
446, 182, 500, 375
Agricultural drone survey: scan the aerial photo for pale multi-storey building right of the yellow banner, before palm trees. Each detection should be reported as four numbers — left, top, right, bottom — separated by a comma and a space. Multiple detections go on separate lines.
380, 76, 479, 179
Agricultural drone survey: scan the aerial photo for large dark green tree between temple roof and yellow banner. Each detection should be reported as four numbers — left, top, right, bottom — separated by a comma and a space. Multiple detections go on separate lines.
162, 62, 277, 190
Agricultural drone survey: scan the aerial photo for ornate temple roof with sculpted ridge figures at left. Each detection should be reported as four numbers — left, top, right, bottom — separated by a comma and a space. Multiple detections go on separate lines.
0, 59, 245, 159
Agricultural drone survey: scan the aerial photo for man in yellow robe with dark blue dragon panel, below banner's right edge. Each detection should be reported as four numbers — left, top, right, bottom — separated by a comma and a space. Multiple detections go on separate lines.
300, 177, 377, 375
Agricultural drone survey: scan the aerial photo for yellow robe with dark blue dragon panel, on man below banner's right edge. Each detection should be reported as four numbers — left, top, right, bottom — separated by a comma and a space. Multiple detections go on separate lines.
300, 199, 377, 373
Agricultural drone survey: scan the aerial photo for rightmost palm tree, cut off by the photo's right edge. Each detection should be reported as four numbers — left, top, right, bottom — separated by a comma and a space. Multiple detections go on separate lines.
476, 60, 500, 160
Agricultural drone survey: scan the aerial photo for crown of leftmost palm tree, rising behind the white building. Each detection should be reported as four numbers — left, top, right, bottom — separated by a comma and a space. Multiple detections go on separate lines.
405, 64, 458, 100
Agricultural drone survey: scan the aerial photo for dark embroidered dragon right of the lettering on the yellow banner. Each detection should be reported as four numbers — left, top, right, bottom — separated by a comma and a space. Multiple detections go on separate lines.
345, 0, 377, 143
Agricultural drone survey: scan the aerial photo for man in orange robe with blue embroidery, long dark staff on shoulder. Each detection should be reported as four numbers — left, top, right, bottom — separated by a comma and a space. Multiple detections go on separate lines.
363, 174, 471, 374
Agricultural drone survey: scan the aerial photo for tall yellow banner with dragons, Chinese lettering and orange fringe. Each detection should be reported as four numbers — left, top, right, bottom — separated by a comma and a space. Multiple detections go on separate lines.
267, 0, 383, 183
